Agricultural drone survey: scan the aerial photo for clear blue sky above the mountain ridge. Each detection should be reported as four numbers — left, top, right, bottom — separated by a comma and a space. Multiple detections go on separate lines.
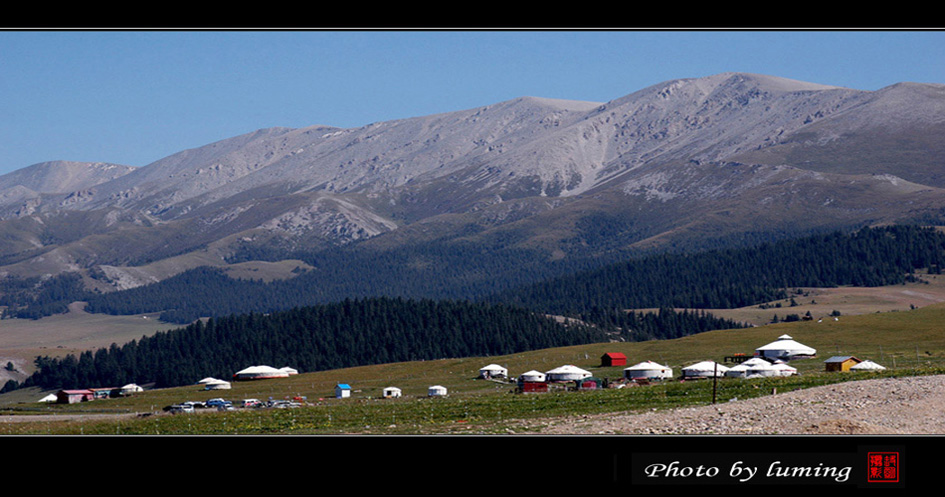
0, 30, 945, 174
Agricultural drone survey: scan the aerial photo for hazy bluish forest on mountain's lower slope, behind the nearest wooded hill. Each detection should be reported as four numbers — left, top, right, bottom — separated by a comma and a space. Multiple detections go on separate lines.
83, 243, 599, 324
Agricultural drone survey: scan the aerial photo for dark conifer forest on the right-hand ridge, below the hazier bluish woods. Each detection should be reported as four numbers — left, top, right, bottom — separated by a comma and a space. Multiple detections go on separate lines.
491, 226, 945, 315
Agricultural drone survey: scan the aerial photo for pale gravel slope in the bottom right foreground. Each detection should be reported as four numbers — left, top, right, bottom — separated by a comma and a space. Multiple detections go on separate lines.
522, 376, 945, 435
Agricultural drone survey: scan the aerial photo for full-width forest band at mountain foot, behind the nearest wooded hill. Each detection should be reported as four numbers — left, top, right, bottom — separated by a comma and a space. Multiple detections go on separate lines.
6, 226, 945, 324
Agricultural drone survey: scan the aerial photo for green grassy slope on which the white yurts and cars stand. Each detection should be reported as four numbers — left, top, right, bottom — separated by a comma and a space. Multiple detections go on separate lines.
0, 298, 945, 435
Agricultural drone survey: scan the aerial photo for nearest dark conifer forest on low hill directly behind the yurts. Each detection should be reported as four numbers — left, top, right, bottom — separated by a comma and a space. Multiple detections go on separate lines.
14, 298, 606, 389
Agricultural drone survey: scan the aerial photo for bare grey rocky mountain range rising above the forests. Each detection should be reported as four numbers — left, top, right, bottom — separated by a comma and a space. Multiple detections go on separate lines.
0, 73, 945, 300
